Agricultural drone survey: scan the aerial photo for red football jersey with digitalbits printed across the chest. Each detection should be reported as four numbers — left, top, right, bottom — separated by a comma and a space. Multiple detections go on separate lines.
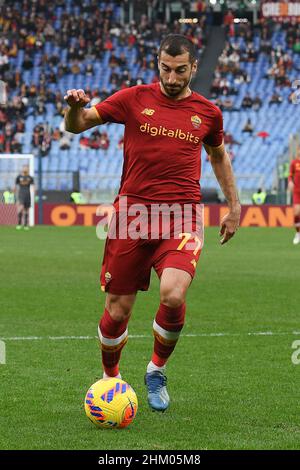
95, 83, 223, 203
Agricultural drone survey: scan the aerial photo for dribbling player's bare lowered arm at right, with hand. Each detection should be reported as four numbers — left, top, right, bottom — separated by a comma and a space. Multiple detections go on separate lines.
203, 143, 241, 245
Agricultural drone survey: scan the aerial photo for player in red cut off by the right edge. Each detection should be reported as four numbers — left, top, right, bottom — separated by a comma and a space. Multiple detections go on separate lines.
288, 147, 300, 245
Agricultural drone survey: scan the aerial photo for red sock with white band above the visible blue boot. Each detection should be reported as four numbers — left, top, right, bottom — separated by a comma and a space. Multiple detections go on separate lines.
151, 303, 185, 367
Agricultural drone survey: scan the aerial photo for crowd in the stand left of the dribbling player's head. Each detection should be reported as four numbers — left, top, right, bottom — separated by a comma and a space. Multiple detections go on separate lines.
0, 0, 206, 155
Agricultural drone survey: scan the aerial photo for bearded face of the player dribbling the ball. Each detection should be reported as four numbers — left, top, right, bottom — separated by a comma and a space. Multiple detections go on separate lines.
158, 51, 197, 99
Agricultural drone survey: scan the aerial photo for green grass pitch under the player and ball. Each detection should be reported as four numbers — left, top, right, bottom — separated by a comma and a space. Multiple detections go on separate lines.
0, 227, 300, 450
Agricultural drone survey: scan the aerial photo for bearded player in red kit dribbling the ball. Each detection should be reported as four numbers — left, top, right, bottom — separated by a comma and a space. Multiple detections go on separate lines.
65, 34, 240, 411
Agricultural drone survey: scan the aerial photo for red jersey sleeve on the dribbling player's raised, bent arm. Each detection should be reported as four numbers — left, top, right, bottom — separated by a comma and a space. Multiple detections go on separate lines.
95, 87, 135, 124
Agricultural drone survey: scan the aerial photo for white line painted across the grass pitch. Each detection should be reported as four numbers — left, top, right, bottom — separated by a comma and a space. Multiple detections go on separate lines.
0, 331, 300, 341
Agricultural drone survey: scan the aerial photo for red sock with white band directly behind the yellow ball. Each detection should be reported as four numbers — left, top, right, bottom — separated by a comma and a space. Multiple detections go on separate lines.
98, 309, 129, 377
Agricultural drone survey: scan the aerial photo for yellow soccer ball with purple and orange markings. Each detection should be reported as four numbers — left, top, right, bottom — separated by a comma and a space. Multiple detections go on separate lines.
84, 378, 138, 428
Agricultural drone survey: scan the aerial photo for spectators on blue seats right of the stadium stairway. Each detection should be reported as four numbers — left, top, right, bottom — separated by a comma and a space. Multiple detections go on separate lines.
210, 11, 300, 170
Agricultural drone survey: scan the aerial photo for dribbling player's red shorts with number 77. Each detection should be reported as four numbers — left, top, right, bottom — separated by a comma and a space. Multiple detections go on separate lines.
100, 204, 203, 295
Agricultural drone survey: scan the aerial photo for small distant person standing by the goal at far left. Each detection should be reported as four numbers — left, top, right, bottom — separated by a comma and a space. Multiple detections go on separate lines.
15, 165, 34, 230
